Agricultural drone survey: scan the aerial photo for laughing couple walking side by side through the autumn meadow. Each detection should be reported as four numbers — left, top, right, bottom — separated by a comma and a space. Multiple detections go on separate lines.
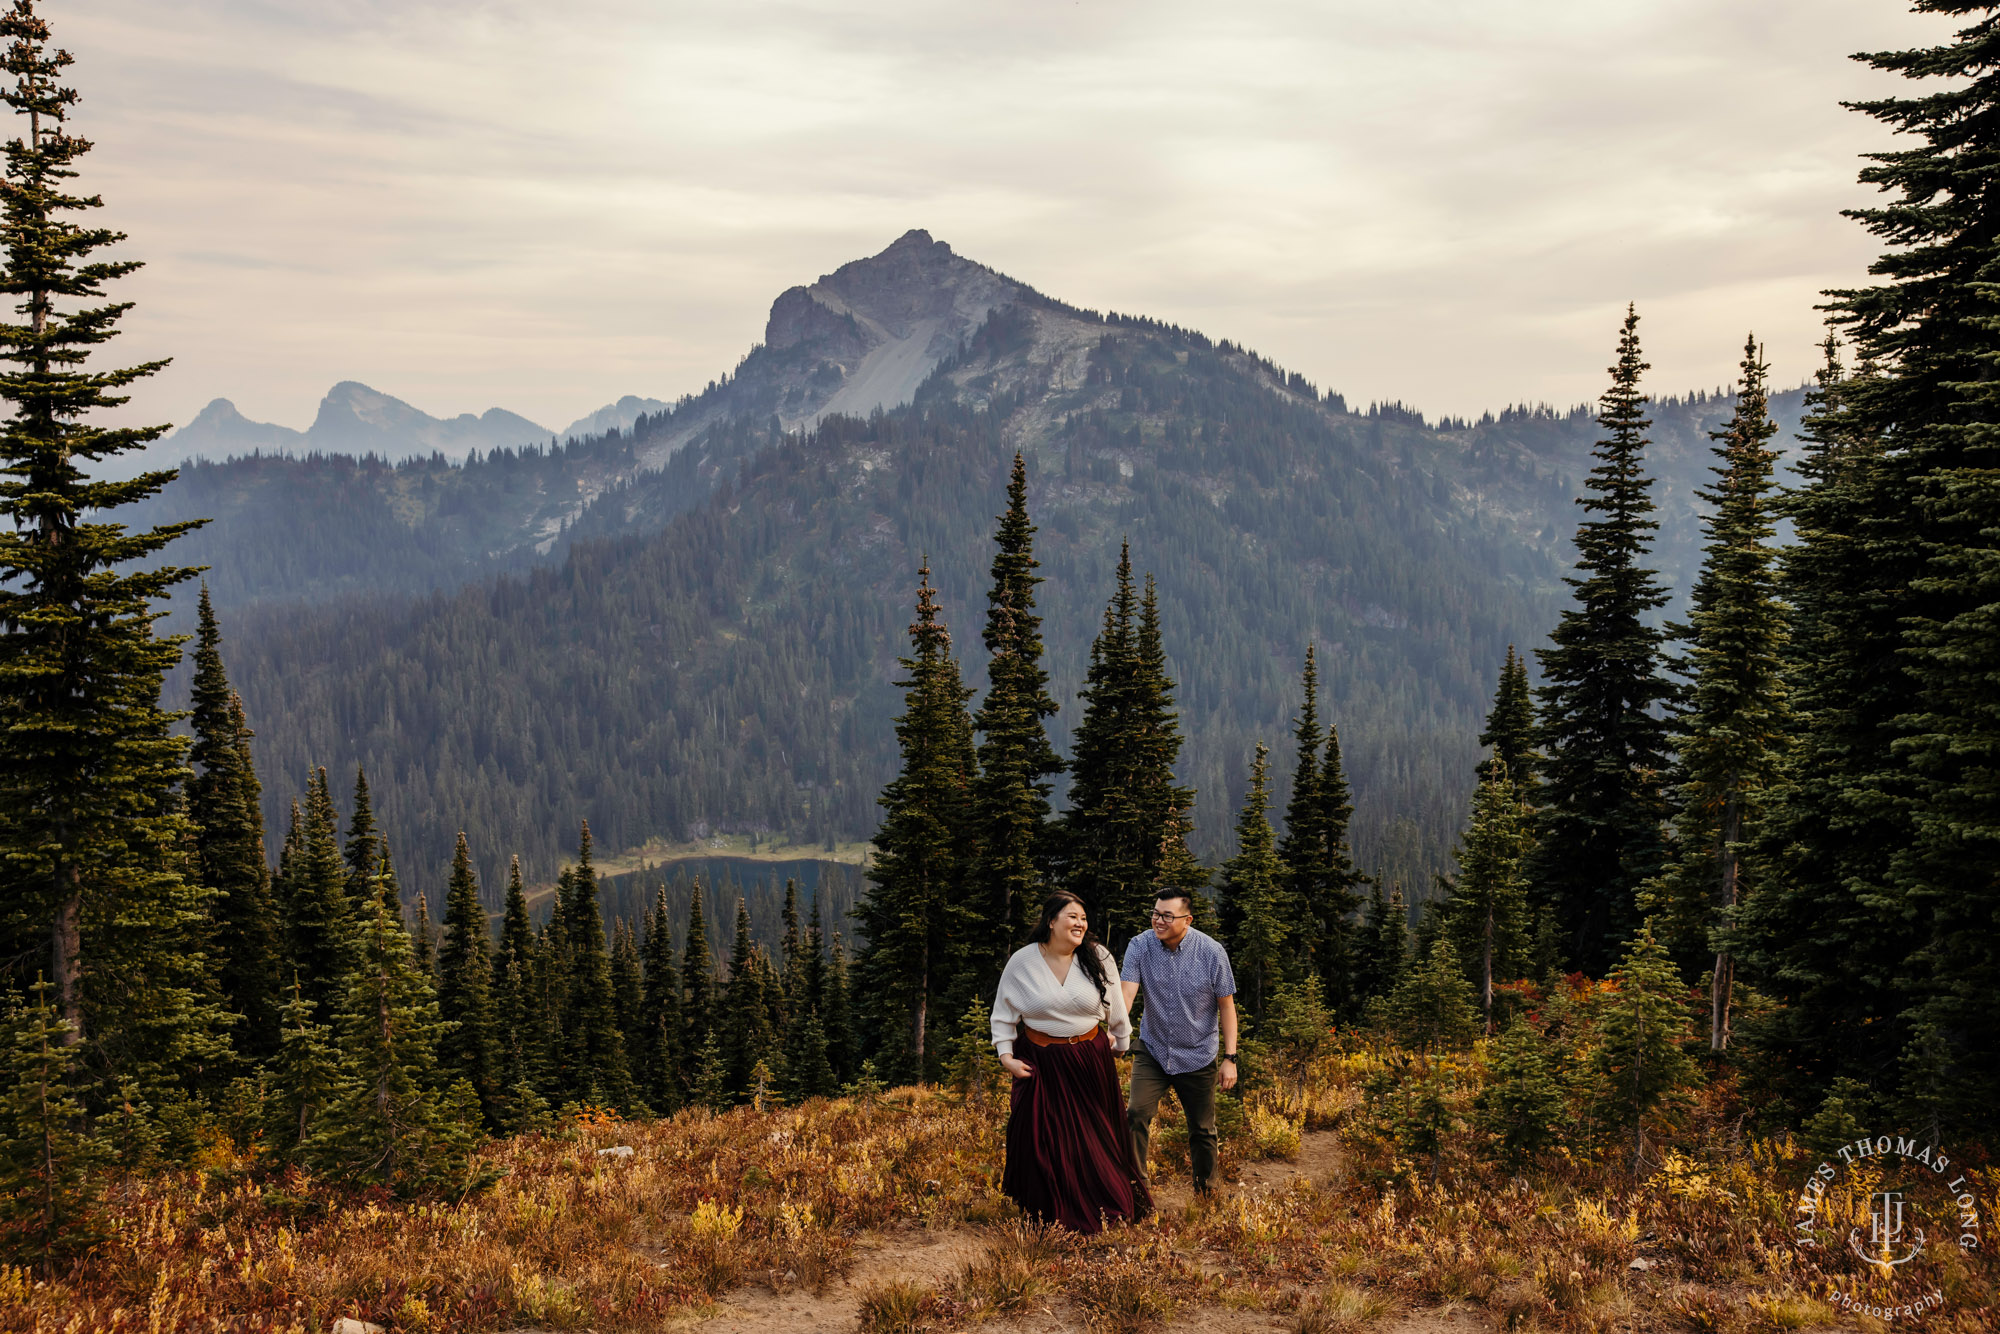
992, 890, 1236, 1232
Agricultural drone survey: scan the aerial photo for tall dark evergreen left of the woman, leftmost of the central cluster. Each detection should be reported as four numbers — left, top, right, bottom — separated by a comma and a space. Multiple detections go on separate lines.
856, 562, 982, 1080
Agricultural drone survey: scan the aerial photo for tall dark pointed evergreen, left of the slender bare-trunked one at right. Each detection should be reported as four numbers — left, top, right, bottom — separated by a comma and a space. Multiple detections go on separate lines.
1530, 310, 1674, 972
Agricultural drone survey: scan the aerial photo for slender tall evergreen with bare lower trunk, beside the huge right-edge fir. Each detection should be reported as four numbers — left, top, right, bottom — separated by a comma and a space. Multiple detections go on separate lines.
1646, 338, 1790, 1052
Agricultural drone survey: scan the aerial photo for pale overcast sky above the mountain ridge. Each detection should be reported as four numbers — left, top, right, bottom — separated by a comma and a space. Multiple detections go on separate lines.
70, 0, 1948, 426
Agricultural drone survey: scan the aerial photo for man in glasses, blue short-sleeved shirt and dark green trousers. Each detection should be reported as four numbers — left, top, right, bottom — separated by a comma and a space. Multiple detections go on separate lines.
1118, 890, 1236, 1194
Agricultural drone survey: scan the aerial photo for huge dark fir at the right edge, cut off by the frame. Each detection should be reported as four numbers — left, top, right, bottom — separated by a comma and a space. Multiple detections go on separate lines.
1752, 0, 2000, 1136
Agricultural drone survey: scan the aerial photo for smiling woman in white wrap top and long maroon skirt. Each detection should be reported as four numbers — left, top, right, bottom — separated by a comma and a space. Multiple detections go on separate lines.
994, 892, 1152, 1232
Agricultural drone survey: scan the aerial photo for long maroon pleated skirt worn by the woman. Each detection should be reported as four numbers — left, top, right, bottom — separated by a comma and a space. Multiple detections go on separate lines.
1000, 1028, 1152, 1234
